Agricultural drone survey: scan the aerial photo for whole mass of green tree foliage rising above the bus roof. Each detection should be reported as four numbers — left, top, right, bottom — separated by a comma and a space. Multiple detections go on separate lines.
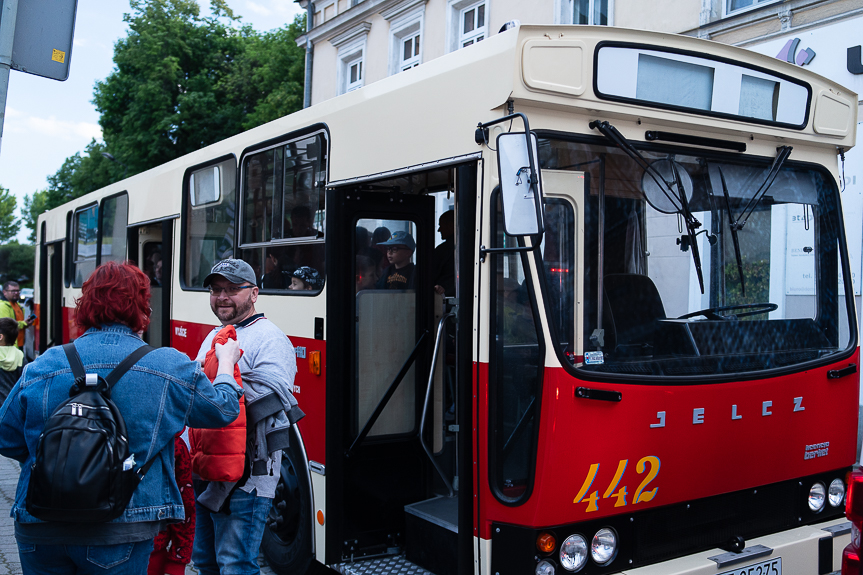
24, 0, 305, 241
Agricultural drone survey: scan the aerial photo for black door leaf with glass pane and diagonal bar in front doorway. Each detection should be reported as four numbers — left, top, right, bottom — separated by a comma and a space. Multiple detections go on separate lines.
326, 190, 435, 564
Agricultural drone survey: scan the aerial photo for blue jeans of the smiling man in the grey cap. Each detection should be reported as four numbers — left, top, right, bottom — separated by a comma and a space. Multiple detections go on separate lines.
192, 485, 273, 575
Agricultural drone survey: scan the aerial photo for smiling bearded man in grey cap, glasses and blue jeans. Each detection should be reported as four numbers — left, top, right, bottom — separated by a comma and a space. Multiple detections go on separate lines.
192, 259, 305, 575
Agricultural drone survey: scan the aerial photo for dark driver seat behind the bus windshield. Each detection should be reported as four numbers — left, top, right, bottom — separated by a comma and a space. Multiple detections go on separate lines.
603, 274, 667, 357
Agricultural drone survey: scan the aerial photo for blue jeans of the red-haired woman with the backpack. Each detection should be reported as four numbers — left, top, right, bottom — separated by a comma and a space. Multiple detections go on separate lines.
18, 539, 153, 575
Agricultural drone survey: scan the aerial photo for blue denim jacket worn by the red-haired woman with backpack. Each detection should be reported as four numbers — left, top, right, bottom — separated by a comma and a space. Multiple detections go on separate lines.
0, 324, 240, 527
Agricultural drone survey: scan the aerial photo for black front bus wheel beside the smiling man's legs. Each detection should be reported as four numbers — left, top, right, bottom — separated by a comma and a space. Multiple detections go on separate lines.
261, 441, 313, 575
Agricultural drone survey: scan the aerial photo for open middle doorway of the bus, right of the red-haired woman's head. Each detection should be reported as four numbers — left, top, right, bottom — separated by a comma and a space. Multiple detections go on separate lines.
128, 219, 174, 347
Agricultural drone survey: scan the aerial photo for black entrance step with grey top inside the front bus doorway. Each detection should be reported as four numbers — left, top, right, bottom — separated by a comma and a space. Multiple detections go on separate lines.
405, 496, 458, 575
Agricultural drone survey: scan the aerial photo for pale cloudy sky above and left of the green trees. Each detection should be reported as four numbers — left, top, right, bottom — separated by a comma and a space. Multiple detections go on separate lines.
0, 0, 301, 242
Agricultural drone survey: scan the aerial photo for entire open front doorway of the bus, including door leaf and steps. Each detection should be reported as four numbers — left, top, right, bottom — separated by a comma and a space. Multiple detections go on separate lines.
318, 163, 477, 575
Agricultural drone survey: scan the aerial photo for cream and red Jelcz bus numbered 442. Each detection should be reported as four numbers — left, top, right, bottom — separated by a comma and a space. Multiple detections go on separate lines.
36, 25, 860, 575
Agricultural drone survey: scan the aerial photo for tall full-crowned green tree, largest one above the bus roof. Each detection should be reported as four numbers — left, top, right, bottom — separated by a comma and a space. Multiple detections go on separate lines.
93, 0, 248, 173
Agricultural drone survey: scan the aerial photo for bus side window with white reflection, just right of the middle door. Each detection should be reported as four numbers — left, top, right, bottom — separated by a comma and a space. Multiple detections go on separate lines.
182, 157, 237, 288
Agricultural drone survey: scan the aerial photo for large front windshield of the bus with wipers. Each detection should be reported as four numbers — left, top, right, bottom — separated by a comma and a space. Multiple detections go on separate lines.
539, 139, 853, 378
